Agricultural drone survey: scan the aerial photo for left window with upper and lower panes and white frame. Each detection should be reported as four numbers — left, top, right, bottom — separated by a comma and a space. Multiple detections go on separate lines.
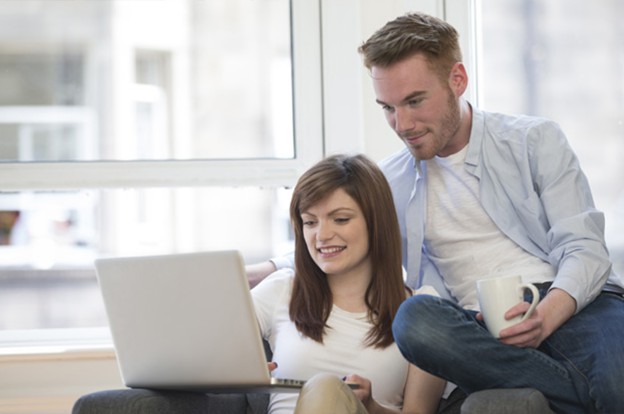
0, 0, 323, 330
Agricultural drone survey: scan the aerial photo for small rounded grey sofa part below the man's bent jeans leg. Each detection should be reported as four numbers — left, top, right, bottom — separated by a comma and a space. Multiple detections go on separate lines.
461, 388, 553, 414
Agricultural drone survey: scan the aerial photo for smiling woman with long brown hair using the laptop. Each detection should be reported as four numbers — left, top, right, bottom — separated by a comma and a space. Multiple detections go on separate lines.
252, 155, 445, 413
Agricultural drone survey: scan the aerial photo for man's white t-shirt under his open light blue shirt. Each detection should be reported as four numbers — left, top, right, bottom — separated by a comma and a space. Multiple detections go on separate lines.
425, 146, 555, 310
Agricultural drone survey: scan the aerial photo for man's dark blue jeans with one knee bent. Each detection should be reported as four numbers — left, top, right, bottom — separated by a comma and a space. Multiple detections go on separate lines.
392, 292, 624, 414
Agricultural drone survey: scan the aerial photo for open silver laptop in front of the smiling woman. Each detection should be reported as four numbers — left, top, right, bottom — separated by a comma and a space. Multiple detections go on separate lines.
95, 250, 303, 392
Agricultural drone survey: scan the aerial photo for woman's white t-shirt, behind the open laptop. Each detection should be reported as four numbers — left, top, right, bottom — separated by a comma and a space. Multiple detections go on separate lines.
251, 269, 408, 414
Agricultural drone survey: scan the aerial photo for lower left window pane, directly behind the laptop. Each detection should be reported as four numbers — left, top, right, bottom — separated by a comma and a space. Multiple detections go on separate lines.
0, 188, 293, 330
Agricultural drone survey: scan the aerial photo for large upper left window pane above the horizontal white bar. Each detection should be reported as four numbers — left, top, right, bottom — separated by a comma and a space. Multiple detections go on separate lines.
0, 0, 295, 161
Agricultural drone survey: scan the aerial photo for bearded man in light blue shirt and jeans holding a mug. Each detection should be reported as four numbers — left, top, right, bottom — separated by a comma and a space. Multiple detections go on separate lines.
250, 13, 624, 413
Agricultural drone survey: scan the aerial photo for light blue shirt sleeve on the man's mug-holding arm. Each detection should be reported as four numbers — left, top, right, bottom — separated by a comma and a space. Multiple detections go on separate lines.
526, 119, 611, 312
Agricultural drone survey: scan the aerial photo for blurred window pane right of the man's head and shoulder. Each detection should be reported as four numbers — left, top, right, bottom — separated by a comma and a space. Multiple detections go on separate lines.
480, 0, 624, 274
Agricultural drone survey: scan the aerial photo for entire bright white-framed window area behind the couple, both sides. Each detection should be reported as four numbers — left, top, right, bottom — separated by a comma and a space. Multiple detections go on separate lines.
7, 0, 624, 340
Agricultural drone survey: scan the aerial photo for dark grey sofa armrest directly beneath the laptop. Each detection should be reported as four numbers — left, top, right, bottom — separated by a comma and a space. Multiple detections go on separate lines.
72, 389, 269, 414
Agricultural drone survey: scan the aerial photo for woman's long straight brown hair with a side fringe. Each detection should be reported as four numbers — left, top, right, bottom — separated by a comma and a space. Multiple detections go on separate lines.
290, 155, 407, 348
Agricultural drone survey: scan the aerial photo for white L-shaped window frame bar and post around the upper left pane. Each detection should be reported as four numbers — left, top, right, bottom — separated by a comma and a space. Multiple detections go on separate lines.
0, 0, 324, 191
